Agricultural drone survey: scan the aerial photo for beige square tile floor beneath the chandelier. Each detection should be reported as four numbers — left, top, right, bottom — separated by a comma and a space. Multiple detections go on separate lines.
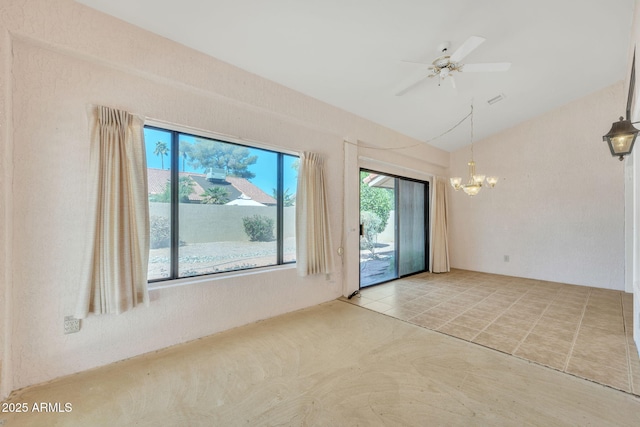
345, 270, 640, 395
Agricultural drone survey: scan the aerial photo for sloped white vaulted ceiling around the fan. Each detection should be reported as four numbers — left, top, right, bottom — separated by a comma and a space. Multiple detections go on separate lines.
77, 0, 634, 151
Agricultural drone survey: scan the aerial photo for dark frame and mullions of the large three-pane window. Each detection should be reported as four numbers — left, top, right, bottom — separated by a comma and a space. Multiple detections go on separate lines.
143, 119, 300, 288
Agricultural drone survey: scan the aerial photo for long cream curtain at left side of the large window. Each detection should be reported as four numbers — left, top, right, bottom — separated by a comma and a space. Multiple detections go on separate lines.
75, 106, 149, 319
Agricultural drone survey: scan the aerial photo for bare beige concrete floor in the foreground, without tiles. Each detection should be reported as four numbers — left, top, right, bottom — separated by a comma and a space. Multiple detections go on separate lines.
0, 301, 640, 427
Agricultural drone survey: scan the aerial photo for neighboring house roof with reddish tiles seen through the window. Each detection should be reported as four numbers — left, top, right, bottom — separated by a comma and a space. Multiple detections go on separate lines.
147, 168, 277, 205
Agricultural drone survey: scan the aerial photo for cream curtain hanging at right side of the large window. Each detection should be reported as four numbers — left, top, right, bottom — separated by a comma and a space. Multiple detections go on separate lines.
296, 153, 333, 276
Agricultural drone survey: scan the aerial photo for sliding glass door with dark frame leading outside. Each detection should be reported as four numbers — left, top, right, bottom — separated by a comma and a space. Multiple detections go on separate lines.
360, 169, 428, 288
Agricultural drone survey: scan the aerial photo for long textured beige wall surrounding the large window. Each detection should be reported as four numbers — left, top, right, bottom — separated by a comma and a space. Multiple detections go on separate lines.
0, 0, 449, 396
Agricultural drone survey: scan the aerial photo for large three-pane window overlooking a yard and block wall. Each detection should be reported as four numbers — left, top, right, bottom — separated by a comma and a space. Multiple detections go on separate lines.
145, 126, 298, 282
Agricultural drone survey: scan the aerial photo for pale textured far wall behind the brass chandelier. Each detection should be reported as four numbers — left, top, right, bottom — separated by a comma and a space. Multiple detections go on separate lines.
450, 82, 626, 290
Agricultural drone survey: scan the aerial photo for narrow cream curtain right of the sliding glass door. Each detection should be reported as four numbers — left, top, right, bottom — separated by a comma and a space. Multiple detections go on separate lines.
431, 177, 451, 273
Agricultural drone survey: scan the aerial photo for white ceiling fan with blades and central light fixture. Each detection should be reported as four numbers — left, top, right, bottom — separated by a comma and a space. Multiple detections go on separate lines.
396, 36, 511, 96
